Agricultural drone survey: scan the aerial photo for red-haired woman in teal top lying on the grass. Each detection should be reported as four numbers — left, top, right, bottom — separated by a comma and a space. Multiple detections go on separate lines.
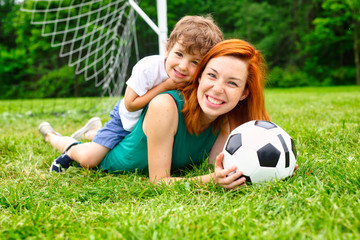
40, 40, 269, 189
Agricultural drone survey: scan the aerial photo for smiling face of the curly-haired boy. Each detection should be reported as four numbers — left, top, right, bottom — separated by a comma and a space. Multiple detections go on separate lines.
165, 43, 201, 83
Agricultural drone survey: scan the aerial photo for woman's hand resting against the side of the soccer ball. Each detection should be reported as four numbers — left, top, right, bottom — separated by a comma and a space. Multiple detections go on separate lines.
213, 153, 246, 189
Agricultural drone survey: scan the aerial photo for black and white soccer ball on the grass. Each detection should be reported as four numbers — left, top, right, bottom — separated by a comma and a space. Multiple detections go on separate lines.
223, 120, 296, 183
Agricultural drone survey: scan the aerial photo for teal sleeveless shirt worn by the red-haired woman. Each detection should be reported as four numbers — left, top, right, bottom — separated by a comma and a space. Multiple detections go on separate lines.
99, 90, 218, 173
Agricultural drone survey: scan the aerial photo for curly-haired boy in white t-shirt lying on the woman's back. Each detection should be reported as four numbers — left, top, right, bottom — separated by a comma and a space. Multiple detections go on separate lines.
39, 16, 223, 172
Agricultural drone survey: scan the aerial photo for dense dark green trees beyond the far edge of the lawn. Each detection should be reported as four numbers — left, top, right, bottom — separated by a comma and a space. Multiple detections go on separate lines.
0, 0, 360, 99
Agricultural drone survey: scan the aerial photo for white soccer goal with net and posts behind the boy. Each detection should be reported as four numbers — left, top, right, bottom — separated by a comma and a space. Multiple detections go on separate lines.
21, 0, 167, 96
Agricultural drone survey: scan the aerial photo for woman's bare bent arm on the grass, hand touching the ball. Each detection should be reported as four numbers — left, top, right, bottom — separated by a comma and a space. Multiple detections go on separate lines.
143, 94, 245, 188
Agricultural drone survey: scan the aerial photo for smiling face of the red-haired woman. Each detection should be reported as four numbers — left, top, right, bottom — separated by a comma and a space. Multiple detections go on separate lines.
197, 56, 248, 121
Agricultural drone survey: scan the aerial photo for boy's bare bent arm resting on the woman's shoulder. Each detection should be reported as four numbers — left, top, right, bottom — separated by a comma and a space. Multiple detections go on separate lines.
124, 78, 186, 112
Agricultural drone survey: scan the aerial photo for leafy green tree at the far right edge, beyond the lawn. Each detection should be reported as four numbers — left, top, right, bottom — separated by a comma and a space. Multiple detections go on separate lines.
303, 0, 360, 84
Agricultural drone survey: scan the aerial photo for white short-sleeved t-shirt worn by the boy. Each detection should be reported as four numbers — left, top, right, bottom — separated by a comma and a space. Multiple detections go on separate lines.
119, 55, 169, 131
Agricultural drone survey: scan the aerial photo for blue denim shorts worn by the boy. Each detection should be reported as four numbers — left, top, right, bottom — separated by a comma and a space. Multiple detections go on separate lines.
92, 100, 130, 149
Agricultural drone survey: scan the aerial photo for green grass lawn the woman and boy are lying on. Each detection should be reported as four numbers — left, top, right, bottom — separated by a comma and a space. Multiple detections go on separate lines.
0, 87, 360, 239
